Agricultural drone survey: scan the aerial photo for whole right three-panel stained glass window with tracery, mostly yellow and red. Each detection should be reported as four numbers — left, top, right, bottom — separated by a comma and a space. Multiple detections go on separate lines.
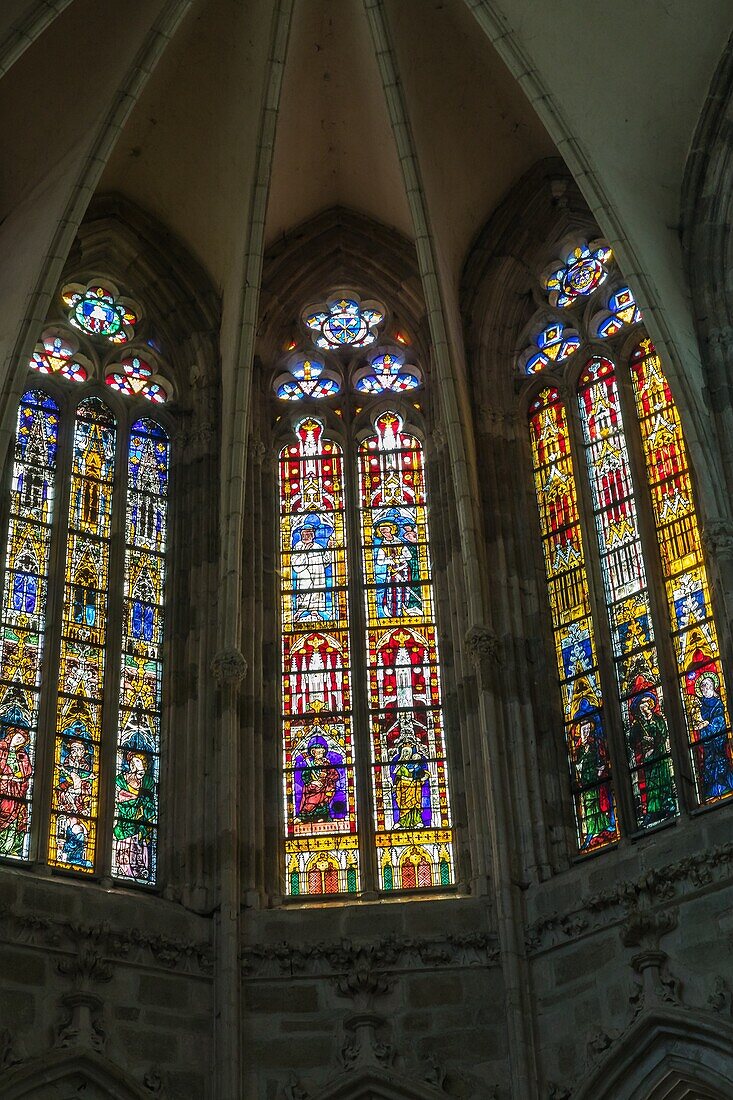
517, 241, 733, 853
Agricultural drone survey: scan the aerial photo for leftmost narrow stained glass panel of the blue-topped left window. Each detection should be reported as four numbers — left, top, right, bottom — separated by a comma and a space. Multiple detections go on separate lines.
0, 389, 58, 859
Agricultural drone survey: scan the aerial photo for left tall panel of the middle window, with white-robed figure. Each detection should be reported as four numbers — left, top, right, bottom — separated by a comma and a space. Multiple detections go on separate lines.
280, 417, 360, 895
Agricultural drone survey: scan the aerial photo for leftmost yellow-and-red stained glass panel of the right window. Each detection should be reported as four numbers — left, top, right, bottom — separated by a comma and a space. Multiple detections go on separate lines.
529, 388, 619, 851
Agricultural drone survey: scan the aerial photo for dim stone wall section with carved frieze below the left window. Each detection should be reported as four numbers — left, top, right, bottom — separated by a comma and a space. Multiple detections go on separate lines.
0, 868, 214, 1098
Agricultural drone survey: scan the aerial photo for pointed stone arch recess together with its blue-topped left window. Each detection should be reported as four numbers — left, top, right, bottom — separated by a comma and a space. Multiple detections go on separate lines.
2, 197, 218, 902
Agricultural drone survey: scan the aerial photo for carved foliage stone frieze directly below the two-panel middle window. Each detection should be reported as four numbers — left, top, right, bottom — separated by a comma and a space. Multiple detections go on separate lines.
242, 932, 499, 990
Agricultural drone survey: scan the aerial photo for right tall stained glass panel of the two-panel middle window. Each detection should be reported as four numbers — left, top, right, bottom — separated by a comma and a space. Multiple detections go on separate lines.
359, 411, 455, 890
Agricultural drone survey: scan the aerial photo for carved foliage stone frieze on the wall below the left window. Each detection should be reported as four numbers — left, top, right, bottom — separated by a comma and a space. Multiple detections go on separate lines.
0, 906, 214, 988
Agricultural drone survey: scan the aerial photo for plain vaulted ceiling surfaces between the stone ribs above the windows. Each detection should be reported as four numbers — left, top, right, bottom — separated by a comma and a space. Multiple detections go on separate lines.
0, 0, 733, 409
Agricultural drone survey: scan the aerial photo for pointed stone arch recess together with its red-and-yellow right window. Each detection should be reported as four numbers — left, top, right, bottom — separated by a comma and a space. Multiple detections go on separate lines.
462, 162, 733, 858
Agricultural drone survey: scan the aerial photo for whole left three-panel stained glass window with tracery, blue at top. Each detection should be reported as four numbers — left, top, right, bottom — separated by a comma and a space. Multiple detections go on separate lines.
0, 281, 173, 886
